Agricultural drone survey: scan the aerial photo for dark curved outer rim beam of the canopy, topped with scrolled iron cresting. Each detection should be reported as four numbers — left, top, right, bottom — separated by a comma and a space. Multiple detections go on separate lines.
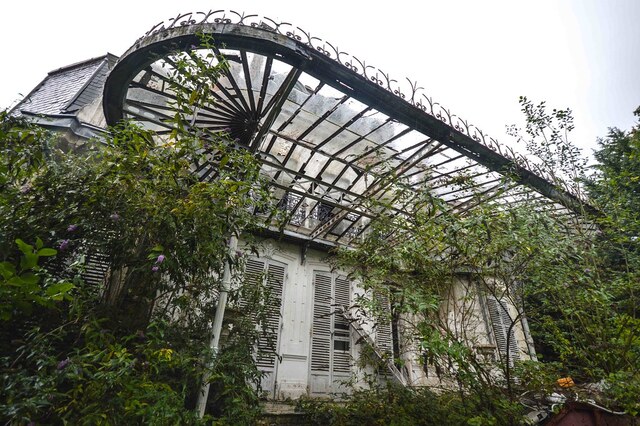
103, 11, 600, 216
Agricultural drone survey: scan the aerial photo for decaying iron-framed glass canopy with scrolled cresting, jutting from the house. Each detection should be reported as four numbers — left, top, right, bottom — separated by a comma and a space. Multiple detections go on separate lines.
104, 11, 592, 245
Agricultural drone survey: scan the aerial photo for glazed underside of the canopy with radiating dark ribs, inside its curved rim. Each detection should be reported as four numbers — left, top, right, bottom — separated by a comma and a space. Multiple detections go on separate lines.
107, 29, 592, 244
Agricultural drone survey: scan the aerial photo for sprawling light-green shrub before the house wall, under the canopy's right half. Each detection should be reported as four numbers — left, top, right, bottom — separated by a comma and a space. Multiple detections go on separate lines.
335, 171, 564, 424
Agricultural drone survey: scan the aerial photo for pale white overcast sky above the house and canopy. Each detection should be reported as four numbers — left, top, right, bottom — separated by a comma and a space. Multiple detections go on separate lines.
0, 0, 640, 158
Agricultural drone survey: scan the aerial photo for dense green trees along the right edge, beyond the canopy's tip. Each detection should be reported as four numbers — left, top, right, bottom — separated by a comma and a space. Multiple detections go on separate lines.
508, 98, 640, 413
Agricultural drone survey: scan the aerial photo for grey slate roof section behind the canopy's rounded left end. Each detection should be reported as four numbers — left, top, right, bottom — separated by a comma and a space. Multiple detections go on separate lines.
12, 53, 118, 115
